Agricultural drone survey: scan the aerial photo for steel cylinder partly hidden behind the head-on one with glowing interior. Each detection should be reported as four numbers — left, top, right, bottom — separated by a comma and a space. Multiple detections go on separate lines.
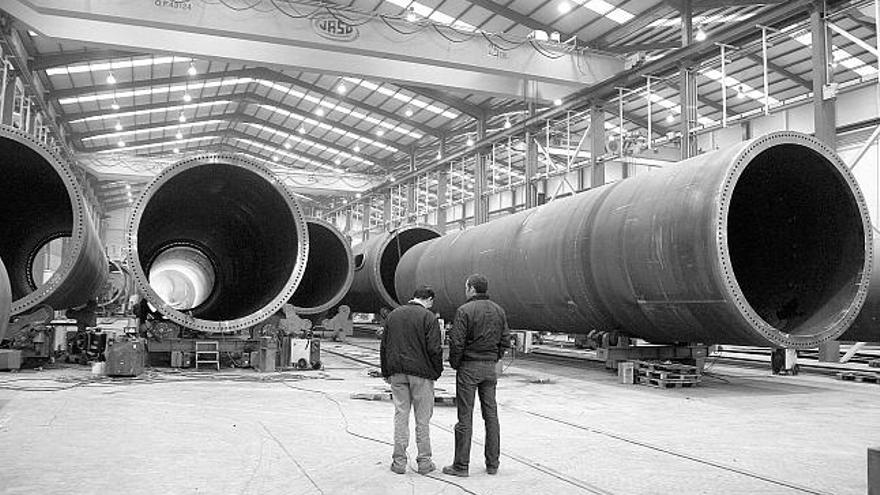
290, 218, 354, 315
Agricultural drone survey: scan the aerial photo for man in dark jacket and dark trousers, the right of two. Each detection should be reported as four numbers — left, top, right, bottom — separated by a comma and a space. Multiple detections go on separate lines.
443, 274, 510, 476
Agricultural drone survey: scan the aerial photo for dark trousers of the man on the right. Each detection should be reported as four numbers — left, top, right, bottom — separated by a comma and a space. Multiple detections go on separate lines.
452, 361, 501, 470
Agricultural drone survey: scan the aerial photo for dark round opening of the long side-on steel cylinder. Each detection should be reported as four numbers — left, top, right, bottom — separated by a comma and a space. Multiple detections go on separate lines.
727, 144, 865, 338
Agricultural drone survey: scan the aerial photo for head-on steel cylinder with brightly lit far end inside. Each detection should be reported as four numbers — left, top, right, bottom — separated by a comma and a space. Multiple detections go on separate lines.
126, 154, 309, 333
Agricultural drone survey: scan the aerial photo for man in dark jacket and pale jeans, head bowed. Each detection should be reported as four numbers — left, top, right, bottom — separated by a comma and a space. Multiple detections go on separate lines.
379, 286, 443, 474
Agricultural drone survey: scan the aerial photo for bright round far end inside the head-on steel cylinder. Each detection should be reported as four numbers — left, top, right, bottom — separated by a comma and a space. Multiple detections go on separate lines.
149, 246, 215, 311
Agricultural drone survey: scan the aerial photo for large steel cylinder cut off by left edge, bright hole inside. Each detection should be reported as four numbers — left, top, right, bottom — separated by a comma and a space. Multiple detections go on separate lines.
0, 126, 108, 315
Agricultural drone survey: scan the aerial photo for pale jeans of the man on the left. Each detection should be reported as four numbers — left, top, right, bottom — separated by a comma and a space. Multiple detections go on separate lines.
388, 373, 434, 467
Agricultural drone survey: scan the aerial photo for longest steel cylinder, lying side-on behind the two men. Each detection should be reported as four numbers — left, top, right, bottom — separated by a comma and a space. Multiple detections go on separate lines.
396, 132, 872, 348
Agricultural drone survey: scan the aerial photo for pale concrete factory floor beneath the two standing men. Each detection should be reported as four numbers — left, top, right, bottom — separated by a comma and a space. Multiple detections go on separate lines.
0, 339, 880, 495
